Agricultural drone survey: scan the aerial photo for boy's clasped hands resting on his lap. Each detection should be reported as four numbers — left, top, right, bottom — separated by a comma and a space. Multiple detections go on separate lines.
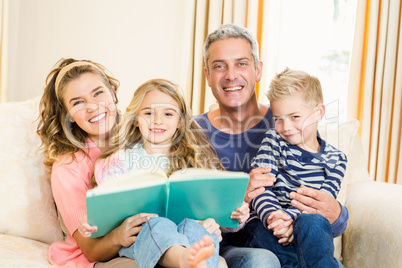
267, 210, 293, 246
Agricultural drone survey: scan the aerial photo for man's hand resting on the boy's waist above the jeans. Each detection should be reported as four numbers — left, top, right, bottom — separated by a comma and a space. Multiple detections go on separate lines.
289, 185, 342, 224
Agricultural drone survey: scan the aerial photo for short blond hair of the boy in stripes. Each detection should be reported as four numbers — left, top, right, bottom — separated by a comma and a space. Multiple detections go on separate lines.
267, 68, 324, 108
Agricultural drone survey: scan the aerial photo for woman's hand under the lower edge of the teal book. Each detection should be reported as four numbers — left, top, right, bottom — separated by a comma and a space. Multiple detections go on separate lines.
112, 213, 158, 247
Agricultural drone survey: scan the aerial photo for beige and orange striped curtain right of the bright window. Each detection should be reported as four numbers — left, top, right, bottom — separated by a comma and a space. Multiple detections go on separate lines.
348, 0, 402, 184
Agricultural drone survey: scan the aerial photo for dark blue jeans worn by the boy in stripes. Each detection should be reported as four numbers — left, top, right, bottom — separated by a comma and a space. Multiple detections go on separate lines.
245, 214, 343, 268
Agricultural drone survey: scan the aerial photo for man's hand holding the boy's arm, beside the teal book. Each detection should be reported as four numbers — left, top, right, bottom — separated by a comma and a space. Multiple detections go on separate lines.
244, 167, 276, 203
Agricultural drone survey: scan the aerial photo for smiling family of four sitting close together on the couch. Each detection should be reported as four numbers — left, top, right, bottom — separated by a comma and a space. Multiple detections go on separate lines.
37, 24, 349, 268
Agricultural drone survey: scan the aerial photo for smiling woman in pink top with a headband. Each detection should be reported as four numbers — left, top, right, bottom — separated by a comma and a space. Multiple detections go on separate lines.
37, 59, 154, 267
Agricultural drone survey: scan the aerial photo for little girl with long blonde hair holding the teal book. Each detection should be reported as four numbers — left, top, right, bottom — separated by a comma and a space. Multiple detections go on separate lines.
80, 79, 249, 267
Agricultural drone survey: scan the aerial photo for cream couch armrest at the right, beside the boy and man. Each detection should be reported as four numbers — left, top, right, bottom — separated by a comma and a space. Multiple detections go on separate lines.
342, 182, 402, 267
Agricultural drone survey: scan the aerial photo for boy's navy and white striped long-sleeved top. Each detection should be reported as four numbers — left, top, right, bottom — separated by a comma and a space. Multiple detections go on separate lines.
249, 129, 347, 227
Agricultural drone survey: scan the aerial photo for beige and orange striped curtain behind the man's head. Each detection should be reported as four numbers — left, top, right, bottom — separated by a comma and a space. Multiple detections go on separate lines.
183, 0, 264, 114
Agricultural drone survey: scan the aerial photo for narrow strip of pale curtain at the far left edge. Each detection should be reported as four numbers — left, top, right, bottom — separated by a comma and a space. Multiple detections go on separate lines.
0, 0, 8, 102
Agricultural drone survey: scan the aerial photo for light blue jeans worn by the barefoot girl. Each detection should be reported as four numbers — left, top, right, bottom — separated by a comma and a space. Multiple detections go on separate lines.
119, 217, 219, 268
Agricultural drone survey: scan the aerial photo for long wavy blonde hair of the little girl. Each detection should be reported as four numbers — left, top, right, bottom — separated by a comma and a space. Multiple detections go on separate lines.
100, 79, 223, 179
